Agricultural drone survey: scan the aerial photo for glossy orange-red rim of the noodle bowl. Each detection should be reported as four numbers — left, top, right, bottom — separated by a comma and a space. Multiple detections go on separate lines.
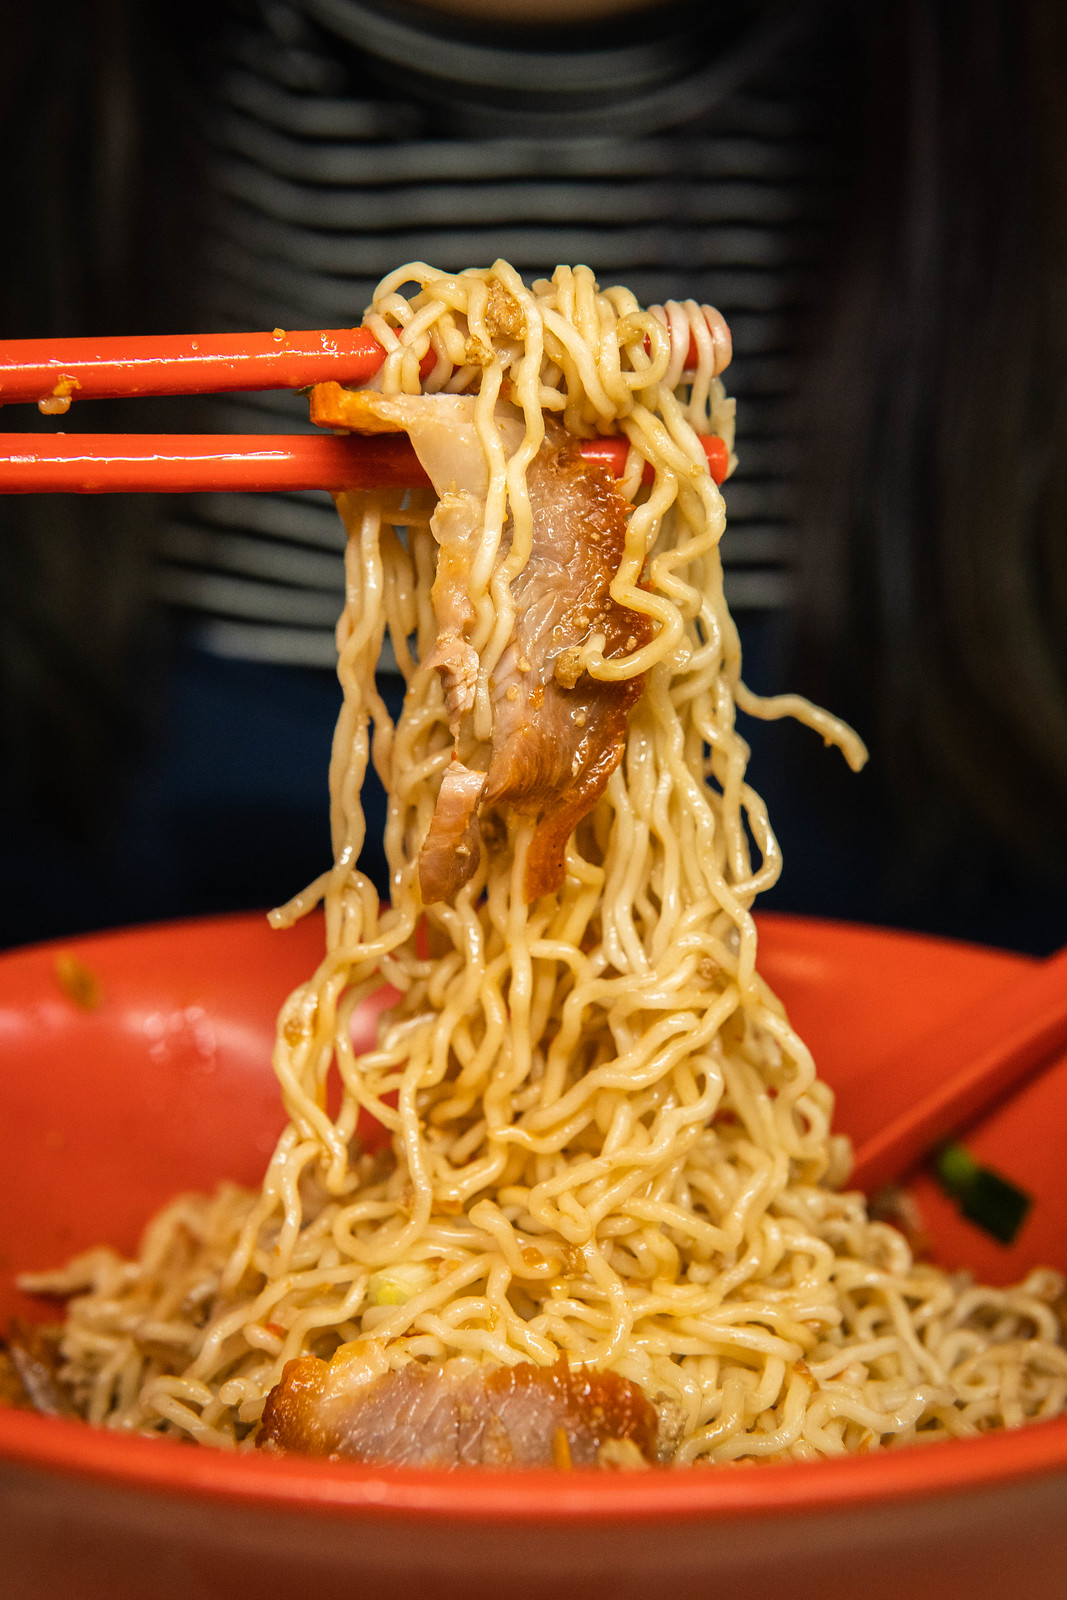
0, 912, 1067, 1525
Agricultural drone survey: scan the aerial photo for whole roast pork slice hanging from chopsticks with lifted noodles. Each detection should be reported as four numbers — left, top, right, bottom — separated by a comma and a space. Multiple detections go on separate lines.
312, 384, 651, 904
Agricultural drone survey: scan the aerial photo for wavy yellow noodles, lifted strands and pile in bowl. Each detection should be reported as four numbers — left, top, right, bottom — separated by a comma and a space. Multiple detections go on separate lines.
26, 262, 1067, 1464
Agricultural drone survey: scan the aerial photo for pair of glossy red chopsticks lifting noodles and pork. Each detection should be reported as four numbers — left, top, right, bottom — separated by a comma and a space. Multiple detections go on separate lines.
0, 328, 728, 494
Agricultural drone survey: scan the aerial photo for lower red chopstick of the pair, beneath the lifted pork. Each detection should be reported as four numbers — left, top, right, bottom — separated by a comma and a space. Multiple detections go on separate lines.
0, 434, 729, 494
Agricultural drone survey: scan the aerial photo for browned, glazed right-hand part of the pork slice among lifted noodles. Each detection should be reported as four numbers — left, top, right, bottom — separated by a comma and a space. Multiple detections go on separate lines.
483, 422, 651, 902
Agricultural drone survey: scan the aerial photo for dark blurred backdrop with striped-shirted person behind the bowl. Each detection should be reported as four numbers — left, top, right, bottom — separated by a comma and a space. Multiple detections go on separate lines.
0, 0, 1067, 952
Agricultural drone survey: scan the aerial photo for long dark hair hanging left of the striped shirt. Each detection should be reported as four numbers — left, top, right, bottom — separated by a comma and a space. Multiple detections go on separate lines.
0, 0, 214, 830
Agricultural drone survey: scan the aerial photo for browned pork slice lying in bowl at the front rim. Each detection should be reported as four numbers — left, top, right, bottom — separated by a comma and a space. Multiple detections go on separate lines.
256, 1347, 659, 1469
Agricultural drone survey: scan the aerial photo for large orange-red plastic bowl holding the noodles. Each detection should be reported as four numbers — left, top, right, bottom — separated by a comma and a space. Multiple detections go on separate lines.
0, 917, 1067, 1600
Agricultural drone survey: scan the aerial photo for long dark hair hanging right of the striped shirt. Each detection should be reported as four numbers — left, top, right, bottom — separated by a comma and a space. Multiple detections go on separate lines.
797, 0, 1067, 906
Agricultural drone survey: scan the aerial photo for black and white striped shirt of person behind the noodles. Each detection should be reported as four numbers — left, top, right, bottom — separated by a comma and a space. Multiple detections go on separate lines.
157, 0, 832, 666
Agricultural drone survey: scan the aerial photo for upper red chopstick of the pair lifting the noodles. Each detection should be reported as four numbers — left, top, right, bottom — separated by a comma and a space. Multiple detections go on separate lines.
0, 328, 710, 405
